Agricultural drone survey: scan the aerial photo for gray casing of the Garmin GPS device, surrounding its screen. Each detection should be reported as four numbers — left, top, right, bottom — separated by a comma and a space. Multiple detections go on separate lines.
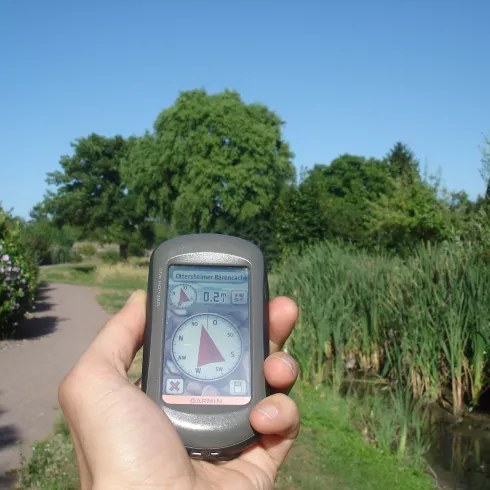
142, 234, 270, 461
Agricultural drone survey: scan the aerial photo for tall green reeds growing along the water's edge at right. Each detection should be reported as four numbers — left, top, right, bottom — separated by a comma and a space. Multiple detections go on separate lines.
274, 239, 490, 416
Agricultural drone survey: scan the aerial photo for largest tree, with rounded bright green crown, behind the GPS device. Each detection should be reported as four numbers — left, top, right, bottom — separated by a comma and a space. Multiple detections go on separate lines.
124, 90, 294, 239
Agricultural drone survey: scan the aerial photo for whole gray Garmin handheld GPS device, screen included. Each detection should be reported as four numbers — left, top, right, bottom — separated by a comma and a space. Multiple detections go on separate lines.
142, 234, 269, 461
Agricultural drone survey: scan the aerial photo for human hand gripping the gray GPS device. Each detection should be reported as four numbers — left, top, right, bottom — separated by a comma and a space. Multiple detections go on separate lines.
59, 291, 299, 490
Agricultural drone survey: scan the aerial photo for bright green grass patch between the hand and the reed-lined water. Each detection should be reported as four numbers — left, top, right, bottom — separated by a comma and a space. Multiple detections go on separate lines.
277, 384, 435, 490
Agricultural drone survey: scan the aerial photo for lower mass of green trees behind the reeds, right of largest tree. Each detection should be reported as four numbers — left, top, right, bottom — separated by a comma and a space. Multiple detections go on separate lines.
272, 143, 464, 255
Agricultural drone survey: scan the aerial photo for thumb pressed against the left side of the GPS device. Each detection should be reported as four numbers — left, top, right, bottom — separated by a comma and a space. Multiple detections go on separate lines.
84, 290, 146, 376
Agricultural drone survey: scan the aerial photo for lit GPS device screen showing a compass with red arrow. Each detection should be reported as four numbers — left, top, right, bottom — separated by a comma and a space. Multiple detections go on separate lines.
162, 265, 251, 405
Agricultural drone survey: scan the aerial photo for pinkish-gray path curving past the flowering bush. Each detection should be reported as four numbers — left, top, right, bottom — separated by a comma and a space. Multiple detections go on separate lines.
0, 284, 109, 488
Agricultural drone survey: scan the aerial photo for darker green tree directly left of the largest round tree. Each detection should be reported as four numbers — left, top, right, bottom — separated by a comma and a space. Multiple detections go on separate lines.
43, 134, 152, 258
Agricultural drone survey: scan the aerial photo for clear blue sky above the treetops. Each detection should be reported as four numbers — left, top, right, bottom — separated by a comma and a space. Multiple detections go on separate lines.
0, 0, 490, 217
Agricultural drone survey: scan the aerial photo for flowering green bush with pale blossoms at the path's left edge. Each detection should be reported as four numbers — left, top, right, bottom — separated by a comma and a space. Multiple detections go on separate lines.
0, 209, 38, 336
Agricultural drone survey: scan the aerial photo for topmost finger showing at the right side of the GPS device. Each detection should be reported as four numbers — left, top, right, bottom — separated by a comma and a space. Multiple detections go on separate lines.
269, 296, 298, 354
